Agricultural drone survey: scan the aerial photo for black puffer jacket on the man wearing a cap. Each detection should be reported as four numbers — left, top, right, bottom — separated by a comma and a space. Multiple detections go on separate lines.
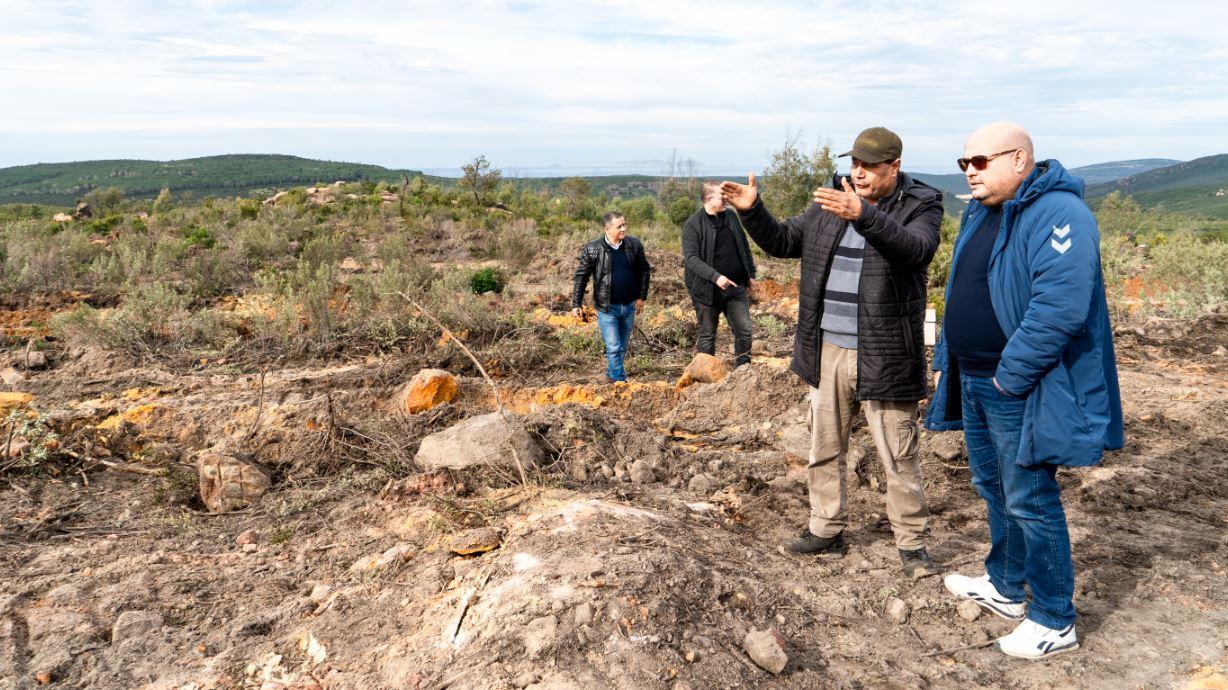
739, 173, 943, 401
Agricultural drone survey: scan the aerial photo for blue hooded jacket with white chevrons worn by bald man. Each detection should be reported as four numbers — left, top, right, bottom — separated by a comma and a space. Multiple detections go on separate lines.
925, 160, 1125, 467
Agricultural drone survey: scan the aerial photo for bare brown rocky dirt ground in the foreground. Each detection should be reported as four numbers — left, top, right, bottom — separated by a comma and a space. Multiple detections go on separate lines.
0, 277, 1228, 690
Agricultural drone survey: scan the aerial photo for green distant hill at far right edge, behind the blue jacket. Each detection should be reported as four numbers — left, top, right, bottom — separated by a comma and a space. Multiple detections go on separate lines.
1087, 153, 1228, 219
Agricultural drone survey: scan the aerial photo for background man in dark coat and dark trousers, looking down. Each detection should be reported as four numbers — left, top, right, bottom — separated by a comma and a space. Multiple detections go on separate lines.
683, 182, 755, 366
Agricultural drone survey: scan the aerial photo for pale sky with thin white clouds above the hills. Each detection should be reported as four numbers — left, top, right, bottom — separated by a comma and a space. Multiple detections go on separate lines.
0, 0, 1228, 174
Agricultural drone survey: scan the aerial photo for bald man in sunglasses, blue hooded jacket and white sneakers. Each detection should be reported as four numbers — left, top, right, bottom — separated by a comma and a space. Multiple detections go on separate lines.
926, 123, 1125, 659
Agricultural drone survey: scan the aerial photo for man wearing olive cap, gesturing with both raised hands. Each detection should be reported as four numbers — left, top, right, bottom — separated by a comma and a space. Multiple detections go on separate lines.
721, 126, 943, 578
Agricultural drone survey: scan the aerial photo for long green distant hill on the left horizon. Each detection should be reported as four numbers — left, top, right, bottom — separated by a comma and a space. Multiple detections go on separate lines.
0, 153, 419, 205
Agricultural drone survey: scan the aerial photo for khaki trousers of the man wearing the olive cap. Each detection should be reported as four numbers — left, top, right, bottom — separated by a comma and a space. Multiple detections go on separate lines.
807, 343, 930, 551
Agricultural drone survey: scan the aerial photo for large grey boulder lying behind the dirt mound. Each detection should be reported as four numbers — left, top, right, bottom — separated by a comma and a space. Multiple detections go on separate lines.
414, 413, 542, 470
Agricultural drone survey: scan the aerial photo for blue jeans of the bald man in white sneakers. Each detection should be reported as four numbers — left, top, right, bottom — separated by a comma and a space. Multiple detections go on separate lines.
959, 374, 1075, 630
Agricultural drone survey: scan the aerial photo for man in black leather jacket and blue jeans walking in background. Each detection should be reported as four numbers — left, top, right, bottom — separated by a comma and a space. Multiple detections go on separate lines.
571, 211, 652, 382
